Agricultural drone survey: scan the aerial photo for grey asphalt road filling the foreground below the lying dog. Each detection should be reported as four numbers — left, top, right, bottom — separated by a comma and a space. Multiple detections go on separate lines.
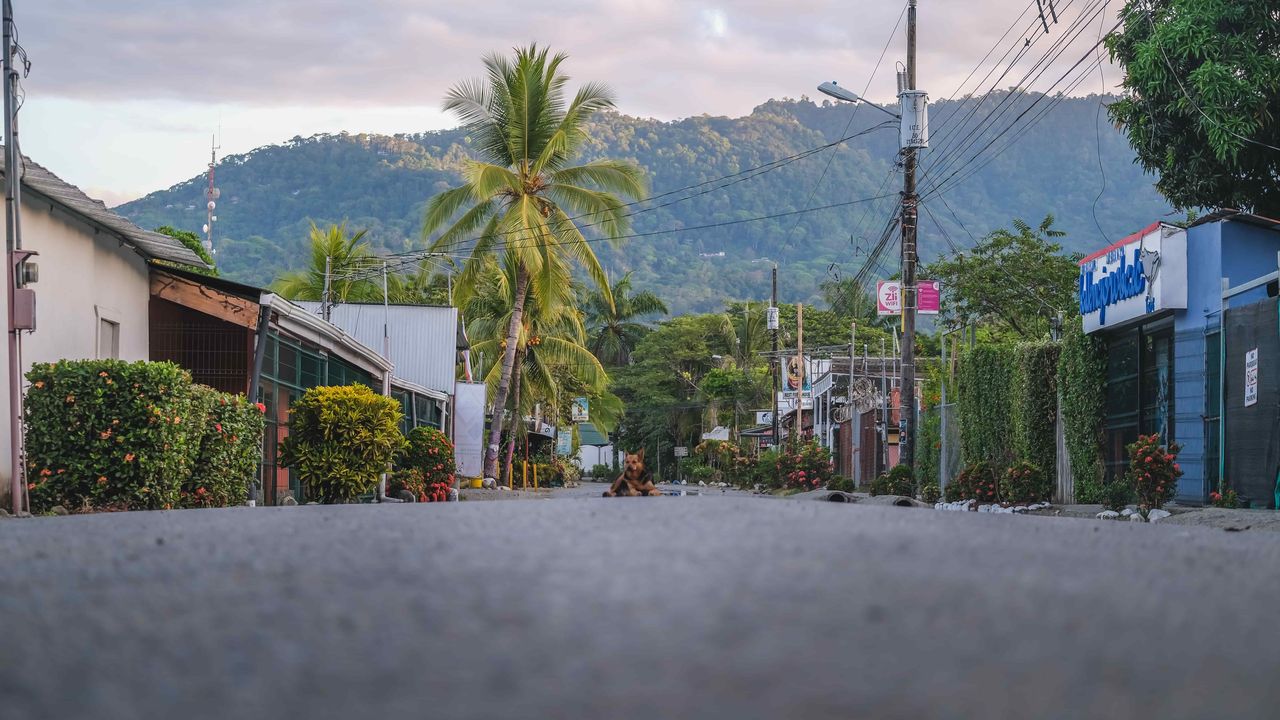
0, 496, 1280, 720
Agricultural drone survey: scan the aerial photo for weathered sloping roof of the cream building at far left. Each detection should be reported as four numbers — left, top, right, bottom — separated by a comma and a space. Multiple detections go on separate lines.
0, 154, 207, 268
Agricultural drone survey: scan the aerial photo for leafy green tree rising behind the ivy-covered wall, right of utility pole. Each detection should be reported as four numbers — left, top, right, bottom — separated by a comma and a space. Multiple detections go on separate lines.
925, 215, 1080, 338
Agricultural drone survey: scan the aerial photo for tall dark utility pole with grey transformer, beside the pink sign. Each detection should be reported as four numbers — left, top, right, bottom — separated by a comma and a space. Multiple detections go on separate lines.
899, 0, 923, 466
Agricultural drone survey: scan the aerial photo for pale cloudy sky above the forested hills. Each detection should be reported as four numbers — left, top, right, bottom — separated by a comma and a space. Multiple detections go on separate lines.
14, 0, 1120, 204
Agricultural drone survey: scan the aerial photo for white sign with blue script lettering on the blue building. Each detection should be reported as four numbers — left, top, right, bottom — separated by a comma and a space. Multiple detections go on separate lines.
1079, 223, 1187, 333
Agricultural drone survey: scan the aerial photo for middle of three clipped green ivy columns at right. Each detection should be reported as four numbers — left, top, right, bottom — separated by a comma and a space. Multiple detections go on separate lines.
1011, 341, 1060, 479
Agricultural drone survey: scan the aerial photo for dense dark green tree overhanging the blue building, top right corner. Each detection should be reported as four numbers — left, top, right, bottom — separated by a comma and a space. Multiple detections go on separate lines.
1107, 0, 1280, 217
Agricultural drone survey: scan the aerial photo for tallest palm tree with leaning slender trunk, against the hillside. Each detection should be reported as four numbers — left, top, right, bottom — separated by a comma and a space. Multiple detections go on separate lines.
422, 45, 645, 477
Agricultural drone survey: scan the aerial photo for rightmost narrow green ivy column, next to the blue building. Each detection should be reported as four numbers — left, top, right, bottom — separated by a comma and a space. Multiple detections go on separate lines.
1057, 318, 1107, 502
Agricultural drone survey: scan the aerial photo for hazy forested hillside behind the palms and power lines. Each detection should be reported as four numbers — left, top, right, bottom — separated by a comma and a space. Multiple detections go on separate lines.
119, 96, 1169, 314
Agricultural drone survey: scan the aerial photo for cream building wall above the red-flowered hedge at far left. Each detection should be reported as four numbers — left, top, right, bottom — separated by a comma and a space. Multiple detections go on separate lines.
0, 196, 151, 499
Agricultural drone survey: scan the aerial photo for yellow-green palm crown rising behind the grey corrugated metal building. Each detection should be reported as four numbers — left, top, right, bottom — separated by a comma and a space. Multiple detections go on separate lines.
271, 223, 383, 302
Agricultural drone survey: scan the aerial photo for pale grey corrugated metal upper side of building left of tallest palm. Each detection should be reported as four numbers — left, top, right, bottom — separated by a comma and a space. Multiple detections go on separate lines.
294, 300, 458, 395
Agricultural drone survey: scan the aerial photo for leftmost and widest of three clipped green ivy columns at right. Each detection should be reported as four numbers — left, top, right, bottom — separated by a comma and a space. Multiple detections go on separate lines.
959, 343, 1016, 468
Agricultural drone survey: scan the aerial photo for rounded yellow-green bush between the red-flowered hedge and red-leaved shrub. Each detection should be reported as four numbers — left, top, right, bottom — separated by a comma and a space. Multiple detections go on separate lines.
280, 386, 404, 502
